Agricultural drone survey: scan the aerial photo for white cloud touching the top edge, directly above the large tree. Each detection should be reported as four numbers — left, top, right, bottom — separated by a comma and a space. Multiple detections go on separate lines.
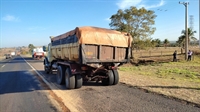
117, 0, 142, 9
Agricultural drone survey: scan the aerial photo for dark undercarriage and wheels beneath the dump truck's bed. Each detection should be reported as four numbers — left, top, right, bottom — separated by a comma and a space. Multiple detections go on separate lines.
44, 58, 119, 89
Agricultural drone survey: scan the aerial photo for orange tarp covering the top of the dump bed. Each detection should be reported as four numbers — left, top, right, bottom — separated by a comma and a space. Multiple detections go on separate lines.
52, 26, 132, 47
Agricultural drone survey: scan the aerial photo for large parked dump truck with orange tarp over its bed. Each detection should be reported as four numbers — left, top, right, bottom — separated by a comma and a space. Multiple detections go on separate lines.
43, 26, 132, 89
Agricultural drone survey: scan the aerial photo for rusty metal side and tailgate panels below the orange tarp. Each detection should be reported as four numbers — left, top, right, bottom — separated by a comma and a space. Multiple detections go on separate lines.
51, 44, 127, 64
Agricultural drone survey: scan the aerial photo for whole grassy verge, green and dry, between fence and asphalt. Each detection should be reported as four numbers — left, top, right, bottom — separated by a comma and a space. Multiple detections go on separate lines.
119, 53, 200, 107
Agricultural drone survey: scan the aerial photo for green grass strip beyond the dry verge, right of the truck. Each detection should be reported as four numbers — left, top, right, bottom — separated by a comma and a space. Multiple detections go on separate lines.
119, 55, 200, 82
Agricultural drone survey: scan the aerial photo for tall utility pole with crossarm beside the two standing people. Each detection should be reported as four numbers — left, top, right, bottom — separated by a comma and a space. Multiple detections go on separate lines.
179, 2, 189, 60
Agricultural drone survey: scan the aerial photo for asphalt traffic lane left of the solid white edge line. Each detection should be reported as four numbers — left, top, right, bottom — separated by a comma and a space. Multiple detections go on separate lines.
0, 56, 59, 112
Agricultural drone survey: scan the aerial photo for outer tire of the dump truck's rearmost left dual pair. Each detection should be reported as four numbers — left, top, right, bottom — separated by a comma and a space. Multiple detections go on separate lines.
65, 68, 75, 89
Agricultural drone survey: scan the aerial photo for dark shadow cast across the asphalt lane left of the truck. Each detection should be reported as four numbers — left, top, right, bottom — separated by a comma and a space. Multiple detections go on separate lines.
0, 71, 50, 95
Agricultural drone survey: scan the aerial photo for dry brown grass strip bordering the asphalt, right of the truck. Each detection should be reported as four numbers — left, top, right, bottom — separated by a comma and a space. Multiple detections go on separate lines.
119, 71, 200, 105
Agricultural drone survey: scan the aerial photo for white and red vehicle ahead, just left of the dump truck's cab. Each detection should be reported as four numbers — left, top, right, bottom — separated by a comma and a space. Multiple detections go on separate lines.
32, 47, 45, 59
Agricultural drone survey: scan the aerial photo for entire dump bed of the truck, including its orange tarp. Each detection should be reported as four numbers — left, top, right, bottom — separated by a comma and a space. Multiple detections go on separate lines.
51, 27, 132, 64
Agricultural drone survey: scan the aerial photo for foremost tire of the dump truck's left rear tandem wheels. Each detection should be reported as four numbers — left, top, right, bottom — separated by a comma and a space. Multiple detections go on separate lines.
57, 65, 65, 85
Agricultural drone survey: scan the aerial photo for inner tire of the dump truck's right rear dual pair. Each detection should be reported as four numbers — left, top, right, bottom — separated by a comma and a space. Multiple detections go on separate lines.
102, 70, 114, 85
